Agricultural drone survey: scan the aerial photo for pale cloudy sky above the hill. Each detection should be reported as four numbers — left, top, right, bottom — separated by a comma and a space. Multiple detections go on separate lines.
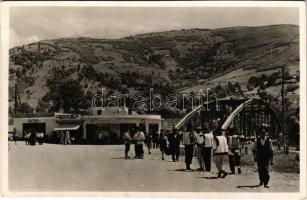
10, 7, 299, 47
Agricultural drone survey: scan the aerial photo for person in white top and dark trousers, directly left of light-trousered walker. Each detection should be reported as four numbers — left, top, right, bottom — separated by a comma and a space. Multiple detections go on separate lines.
203, 127, 214, 172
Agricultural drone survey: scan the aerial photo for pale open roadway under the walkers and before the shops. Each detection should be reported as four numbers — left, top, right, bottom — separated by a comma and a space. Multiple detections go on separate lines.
9, 142, 299, 192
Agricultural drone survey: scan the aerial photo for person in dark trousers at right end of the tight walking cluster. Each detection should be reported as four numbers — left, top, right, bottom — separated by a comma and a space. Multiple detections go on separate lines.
227, 135, 241, 174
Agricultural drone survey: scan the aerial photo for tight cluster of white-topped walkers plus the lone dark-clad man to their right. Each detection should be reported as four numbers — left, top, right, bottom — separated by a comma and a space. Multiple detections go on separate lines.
182, 123, 274, 188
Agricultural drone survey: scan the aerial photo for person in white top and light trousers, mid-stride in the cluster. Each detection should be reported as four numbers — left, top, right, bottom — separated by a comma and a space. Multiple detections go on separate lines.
213, 128, 228, 178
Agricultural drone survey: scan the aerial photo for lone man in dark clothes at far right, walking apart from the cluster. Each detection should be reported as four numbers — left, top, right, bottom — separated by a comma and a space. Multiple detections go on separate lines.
253, 127, 274, 188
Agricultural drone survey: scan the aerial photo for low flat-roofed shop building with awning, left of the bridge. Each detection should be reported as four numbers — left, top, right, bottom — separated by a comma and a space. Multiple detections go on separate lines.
10, 108, 161, 144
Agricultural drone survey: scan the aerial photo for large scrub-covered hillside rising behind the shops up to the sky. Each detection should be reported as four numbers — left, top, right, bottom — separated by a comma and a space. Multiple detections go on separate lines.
10, 25, 299, 111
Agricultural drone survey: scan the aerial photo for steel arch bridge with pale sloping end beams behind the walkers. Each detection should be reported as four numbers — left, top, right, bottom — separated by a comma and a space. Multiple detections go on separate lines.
175, 99, 281, 139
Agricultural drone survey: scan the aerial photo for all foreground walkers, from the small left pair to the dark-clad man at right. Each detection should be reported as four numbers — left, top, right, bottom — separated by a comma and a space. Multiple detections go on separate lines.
123, 122, 274, 187
